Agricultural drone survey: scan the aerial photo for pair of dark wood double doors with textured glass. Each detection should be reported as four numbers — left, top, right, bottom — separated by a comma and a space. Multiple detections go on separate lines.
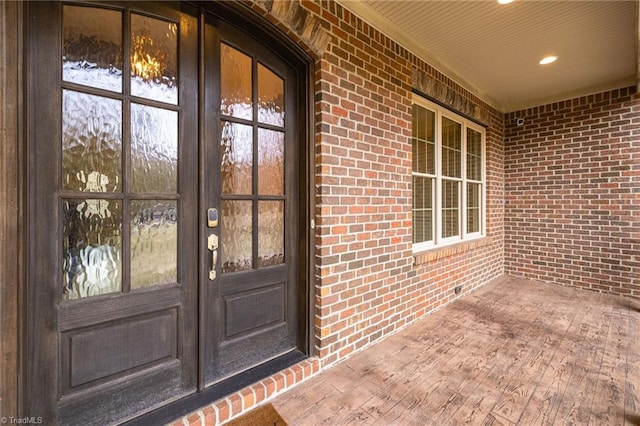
25, 2, 306, 424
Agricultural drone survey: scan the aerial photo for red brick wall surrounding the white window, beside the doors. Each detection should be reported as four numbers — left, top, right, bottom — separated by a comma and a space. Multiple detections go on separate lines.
253, 1, 504, 366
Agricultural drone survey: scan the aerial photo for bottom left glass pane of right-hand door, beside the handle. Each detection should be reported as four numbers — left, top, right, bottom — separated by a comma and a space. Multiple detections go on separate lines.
220, 200, 253, 273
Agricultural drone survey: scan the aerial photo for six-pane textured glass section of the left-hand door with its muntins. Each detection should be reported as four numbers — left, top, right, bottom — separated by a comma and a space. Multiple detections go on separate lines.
61, 5, 178, 300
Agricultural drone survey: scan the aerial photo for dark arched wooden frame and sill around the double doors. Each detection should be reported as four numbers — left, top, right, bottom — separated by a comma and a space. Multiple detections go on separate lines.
10, 2, 316, 424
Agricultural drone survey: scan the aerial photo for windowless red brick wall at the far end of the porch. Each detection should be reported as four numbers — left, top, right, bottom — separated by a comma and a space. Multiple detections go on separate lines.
505, 89, 640, 296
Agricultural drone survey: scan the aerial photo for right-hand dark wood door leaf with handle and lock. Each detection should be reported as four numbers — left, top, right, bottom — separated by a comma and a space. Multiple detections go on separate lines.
202, 20, 300, 384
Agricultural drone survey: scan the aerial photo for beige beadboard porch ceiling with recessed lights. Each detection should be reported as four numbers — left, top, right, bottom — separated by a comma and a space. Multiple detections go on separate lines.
339, 0, 638, 112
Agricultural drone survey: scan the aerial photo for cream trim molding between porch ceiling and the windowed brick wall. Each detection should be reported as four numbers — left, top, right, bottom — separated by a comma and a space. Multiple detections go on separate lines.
335, 0, 504, 112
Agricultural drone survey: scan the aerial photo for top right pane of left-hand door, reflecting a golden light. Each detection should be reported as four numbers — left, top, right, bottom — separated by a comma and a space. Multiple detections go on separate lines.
131, 13, 178, 104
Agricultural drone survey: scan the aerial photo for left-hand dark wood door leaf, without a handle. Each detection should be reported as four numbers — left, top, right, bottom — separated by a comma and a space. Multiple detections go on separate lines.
25, 2, 198, 425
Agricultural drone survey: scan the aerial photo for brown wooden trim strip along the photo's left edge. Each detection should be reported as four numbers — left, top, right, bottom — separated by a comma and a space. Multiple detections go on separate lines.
0, 1, 26, 417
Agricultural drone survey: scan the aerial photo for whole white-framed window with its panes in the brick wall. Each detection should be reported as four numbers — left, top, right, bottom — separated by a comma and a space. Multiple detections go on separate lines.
411, 96, 485, 252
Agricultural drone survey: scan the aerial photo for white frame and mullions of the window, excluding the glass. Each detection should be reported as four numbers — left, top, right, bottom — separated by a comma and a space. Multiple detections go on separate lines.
411, 94, 487, 253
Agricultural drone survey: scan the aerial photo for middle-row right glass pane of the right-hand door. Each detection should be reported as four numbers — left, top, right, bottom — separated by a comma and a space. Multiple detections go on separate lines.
258, 129, 284, 195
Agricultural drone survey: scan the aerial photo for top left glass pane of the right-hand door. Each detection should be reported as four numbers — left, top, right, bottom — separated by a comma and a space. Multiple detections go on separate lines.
220, 43, 253, 120
